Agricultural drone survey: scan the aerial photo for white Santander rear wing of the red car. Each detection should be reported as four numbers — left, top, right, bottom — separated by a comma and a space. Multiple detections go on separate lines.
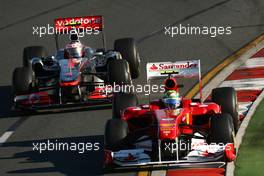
146, 60, 202, 99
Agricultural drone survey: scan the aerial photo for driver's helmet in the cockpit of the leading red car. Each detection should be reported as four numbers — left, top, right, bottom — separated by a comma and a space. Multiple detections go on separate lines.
162, 90, 181, 109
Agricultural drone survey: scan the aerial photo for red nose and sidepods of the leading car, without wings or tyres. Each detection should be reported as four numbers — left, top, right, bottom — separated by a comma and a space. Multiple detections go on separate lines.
122, 99, 221, 140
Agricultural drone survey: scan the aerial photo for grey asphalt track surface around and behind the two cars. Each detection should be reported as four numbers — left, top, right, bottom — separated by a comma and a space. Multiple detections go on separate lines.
0, 0, 264, 176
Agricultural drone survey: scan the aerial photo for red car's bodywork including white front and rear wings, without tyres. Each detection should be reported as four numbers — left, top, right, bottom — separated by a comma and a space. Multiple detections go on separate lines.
104, 62, 236, 168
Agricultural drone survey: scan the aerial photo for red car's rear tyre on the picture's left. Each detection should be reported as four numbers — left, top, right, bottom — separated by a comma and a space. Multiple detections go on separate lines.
112, 93, 138, 119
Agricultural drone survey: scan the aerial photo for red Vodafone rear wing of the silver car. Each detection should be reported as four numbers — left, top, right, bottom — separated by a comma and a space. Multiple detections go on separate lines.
54, 15, 106, 50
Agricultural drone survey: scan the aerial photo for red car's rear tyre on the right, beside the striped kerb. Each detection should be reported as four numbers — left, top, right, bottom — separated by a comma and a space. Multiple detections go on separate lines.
212, 87, 239, 132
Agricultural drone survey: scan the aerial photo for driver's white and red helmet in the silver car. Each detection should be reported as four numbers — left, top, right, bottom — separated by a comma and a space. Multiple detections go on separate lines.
64, 41, 84, 59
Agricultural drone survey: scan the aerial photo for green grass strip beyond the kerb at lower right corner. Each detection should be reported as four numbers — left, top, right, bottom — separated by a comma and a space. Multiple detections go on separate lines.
235, 100, 264, 176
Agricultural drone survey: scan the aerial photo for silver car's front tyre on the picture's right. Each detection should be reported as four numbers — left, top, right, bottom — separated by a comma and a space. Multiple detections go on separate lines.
107, 59, 131, 85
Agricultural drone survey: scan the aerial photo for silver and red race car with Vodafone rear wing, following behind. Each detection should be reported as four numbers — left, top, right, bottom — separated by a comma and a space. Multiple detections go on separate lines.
13, 16, 140, 110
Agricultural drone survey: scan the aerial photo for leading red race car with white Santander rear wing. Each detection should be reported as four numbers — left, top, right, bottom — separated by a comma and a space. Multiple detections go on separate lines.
104, 60, 238, 169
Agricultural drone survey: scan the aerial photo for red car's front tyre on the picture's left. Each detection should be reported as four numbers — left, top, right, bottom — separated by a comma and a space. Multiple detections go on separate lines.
104, 119, 129, 151
